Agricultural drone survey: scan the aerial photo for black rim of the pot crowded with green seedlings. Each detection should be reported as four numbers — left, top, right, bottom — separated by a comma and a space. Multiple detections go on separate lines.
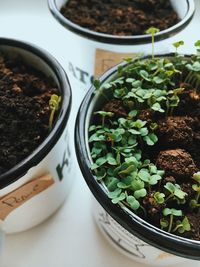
75, 54, 200, 260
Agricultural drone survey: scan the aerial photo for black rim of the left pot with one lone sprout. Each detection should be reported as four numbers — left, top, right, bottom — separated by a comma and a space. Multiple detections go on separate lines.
0, 38, 72, 189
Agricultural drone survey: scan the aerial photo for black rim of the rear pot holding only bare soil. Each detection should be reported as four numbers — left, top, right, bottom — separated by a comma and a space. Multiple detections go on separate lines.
48, 0, 195, 45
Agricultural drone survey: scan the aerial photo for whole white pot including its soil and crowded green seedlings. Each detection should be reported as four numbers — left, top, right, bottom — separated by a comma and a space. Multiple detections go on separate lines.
75, 41, 200, 266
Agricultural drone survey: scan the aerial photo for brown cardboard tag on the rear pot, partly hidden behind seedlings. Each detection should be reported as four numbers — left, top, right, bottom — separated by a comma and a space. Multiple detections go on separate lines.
94, 49, 138, 77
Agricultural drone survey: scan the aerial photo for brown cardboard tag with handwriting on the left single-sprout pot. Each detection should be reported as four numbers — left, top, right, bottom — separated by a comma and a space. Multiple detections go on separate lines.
0, 174, 55, 220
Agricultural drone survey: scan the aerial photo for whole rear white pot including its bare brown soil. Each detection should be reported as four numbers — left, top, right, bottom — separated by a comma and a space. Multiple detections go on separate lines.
48, 0, 195, 96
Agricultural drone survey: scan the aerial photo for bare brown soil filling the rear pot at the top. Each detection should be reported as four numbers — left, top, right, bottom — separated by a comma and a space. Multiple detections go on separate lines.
61, 0, 179, 36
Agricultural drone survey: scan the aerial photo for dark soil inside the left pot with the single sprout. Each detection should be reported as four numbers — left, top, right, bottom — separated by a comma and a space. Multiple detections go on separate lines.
0, 54, 58, 175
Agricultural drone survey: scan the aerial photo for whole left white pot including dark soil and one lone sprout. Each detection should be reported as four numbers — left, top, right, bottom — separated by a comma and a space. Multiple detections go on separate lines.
0, 38, 71, 233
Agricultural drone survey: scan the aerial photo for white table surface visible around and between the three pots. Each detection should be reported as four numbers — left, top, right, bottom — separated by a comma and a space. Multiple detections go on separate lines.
0, 0, 200, 267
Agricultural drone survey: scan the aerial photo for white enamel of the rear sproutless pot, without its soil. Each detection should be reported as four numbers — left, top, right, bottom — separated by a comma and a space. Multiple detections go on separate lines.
48, 0, 195, 99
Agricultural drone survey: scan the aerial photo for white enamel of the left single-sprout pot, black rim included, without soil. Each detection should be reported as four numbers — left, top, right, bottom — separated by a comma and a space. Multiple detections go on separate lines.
0, 38, 72, 233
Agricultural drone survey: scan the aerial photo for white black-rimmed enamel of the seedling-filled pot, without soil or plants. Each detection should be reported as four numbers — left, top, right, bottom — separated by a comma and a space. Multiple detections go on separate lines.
75, 54, 200, 266
